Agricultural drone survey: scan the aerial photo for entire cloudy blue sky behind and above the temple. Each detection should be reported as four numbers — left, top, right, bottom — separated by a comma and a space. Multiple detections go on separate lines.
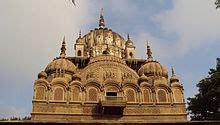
0, 0, 220, 118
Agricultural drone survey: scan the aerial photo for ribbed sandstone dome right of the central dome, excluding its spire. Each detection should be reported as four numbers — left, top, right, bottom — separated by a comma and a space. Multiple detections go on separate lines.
138, 59, 168, 78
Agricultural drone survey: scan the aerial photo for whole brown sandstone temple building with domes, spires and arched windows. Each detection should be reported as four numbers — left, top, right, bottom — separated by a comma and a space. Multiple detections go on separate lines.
31, 9, 187, 122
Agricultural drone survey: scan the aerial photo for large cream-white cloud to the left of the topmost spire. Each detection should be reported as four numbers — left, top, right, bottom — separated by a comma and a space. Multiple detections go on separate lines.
0, 0, 94, 84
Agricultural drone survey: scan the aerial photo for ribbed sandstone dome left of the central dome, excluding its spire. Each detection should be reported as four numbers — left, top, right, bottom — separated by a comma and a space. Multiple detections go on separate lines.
45, 57, 76, 73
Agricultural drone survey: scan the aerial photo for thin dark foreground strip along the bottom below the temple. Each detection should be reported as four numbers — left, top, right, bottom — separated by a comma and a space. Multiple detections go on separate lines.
0, 121, 220, 125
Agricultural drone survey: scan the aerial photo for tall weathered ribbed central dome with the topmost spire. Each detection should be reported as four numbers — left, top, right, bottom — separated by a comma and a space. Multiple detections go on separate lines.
75, 9, 129, 58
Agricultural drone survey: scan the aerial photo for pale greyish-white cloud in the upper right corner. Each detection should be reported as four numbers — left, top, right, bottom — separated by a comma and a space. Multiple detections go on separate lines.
154, 0, 220, 57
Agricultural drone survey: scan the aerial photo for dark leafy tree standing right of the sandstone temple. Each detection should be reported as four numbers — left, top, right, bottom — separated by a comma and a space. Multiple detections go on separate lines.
187, 69, 220, 120
